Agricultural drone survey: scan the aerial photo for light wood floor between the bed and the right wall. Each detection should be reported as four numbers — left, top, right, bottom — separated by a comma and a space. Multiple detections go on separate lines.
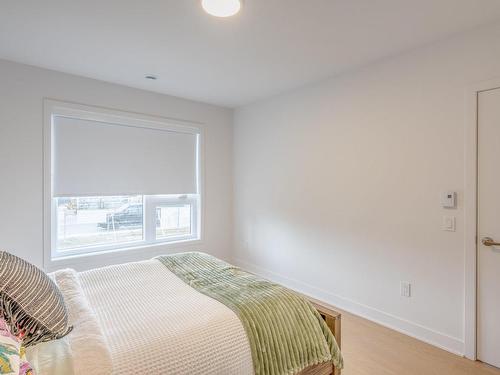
342, 312, 500, 375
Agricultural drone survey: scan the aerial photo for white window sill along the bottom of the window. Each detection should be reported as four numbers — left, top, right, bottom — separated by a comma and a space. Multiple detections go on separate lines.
44, 239, 203, 272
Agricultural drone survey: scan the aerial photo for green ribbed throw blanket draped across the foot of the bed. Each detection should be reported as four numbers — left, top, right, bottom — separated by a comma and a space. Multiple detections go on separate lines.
157, 253, 343, 375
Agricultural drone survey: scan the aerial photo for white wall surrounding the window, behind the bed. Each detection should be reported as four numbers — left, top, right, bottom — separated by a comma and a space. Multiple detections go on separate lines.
0, 60, 233, 269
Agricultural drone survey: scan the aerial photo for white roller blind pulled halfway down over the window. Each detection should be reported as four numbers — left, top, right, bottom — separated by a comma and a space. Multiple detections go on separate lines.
52, 116, 198, 197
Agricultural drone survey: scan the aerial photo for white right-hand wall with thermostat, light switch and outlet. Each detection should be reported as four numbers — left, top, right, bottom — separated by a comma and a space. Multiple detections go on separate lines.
234, 25, 500, 353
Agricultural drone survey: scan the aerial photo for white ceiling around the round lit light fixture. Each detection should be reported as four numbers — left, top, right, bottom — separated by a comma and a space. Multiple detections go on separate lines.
0, 0, 500, 107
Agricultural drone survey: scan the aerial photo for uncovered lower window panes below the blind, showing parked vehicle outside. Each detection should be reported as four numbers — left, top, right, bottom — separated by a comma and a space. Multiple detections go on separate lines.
54, 195, 198, 256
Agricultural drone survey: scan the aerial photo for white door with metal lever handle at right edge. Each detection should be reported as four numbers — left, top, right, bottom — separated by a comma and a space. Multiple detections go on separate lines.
477, 89, 500, 367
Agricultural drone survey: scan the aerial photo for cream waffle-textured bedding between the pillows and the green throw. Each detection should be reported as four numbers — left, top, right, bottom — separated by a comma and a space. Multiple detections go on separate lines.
29, 260, 253, 375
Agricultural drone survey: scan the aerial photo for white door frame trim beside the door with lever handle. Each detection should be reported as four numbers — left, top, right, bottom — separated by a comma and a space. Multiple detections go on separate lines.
464, 78, 500, 360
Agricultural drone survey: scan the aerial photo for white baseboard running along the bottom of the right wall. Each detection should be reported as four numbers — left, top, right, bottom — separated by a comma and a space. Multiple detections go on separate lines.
234, 259, 464, 356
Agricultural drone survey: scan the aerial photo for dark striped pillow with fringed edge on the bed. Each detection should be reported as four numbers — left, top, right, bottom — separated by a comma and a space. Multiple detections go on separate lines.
0, 251, 73, 347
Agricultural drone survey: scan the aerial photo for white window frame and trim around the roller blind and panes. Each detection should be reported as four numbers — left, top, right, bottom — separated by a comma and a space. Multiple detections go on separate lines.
43, 99, 204, 270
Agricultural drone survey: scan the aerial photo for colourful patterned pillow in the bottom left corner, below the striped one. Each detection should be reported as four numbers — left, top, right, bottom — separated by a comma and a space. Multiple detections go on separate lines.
0, 319, 35, 375
